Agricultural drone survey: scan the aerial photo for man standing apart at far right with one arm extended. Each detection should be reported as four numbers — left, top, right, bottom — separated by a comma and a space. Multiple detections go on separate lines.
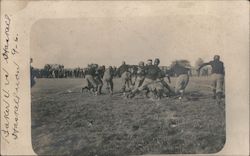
198, 55, 225, 100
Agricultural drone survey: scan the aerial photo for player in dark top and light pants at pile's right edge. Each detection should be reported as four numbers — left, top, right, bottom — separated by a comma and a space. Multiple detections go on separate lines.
170, 61, 190, 99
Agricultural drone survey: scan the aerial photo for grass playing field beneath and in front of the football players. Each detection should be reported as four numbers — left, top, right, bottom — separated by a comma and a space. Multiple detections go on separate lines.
32, 77, 226, 156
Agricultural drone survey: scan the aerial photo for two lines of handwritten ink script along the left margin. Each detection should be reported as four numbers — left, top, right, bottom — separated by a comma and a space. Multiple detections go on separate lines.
1, 14, 21, 143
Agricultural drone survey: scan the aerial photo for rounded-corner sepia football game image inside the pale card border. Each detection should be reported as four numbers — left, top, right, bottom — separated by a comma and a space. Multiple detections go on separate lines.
30, 15, 227, 156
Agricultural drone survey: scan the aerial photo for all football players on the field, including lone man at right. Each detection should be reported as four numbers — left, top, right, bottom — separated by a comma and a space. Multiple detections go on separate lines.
82, 55, 225, 99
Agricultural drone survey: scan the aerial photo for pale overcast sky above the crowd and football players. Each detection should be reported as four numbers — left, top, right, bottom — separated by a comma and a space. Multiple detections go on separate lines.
30, 1, 247, 68
